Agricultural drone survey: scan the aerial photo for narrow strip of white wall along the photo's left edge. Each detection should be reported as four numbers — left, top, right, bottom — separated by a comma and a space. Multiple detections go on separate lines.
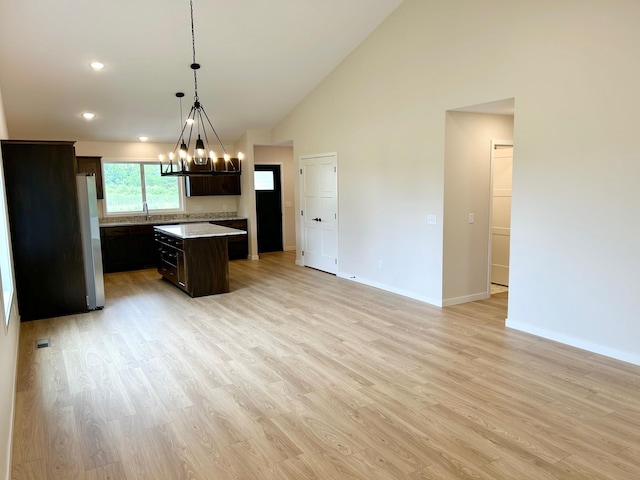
0, 84, 20, 480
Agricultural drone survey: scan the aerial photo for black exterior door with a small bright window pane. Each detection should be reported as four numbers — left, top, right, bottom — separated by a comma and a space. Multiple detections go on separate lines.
255, 165, 282, 253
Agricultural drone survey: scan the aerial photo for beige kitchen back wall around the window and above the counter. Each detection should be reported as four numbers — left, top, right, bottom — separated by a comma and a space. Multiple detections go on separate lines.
75, 141, 238, 218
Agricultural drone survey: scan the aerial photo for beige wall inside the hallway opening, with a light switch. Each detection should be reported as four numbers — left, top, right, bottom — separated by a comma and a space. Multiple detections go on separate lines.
442, 112, 513, 305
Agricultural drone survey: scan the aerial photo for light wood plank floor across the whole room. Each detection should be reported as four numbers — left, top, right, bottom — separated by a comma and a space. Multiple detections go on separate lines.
12, 253, 640, 480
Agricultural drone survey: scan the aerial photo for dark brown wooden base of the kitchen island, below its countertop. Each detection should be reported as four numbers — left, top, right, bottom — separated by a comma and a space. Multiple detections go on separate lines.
155, 232, 229, 297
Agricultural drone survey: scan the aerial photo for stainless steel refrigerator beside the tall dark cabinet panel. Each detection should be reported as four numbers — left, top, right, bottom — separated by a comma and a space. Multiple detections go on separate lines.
76, 173, 104, 310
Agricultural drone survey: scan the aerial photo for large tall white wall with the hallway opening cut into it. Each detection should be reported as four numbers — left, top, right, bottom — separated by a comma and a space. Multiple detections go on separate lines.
272, 0, 640, 363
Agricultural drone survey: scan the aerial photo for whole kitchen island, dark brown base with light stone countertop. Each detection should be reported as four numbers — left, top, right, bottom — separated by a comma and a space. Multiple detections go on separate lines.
154, 223, 247, 297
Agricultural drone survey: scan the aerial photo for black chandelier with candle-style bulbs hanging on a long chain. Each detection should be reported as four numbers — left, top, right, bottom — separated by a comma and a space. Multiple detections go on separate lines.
160, 0, 244, 176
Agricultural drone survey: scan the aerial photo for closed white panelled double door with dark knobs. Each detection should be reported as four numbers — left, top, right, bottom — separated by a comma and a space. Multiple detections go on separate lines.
300, 154, 338, 274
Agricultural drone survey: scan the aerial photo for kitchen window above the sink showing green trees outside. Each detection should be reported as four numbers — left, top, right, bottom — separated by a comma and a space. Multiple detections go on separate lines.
102, 161, 183, 215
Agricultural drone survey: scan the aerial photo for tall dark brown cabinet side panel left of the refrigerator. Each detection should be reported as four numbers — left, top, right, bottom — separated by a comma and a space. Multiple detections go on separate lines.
2, 140, 87, 321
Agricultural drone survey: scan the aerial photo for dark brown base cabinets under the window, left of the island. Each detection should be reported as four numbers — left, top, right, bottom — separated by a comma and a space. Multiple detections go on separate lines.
100, 225, 158, 273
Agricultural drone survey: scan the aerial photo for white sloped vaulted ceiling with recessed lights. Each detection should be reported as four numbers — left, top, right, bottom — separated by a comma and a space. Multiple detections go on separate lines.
0, 0, 402, 143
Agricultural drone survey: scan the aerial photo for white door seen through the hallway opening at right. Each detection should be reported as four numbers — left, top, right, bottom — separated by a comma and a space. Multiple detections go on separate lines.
491, 145, 513, 286
